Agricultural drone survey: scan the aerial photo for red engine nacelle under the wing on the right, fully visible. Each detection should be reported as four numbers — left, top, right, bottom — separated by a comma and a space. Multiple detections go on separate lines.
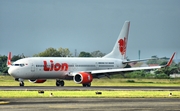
73, 72, 93, 84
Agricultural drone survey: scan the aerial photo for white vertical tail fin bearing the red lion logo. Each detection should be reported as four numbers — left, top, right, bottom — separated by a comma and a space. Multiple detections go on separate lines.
104, 21, 130, 59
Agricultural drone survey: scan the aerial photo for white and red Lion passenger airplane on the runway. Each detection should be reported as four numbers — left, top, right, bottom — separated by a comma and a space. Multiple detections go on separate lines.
7, 21, 175, 87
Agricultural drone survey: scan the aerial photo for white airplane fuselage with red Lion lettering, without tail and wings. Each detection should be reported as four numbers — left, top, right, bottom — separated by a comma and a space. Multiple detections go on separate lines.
8, 57, 125, 79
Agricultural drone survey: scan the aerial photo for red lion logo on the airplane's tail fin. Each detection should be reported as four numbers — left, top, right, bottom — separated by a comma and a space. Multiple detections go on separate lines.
118, 37, 127, 55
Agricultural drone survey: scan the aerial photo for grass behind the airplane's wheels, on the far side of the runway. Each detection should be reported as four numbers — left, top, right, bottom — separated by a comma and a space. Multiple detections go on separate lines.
0, 76, 180, 87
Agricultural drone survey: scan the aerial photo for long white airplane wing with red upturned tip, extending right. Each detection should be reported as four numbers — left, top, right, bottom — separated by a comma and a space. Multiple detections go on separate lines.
91, 53, 175, 75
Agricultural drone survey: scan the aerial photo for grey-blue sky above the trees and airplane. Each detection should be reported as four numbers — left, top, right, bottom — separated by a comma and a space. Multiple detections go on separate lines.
0, 0, 180, 59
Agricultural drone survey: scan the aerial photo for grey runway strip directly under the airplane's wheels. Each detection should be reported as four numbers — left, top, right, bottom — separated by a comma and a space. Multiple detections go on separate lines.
0, 86, 180, 91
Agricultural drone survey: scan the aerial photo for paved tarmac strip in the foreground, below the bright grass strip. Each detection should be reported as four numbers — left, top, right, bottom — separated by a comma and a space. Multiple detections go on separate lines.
0, 98, 180, 111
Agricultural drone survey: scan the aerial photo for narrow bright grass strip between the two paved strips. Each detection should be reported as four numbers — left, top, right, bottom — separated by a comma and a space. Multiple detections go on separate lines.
0, 91, 180, 98
